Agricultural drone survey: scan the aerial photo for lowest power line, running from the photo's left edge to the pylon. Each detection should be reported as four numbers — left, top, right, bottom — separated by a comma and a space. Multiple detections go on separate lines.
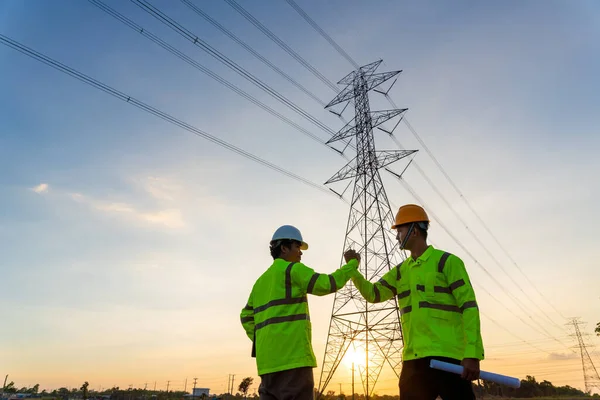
0, 34, 340, 202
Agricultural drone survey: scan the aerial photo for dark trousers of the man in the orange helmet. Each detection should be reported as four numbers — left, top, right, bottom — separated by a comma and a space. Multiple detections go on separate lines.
400, 357, 475, 400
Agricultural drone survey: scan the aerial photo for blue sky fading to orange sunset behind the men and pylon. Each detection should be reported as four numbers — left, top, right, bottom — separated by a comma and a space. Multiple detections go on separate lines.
0, 0, 600, 393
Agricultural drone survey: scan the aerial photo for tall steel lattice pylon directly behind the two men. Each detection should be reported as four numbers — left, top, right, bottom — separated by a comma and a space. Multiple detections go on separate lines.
319, 61, 416, 399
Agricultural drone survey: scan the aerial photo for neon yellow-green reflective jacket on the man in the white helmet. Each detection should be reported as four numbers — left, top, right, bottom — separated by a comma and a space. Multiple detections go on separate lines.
240, 258, 358, 375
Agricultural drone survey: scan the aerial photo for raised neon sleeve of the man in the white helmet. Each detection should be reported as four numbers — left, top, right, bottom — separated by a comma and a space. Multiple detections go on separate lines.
292, 260, 358, 296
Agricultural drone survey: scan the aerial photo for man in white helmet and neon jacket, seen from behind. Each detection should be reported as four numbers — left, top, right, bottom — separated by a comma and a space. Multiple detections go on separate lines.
240, 225, 360, 400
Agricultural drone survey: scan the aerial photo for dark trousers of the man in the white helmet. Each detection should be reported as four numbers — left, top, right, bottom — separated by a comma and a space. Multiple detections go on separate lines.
258, 367, 315, 400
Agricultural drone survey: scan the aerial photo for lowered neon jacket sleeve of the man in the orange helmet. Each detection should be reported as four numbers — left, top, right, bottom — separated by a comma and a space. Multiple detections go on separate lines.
444, 255, 484, 360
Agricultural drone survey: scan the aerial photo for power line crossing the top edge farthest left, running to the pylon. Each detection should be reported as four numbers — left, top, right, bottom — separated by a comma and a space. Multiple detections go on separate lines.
88, 0, 340, 159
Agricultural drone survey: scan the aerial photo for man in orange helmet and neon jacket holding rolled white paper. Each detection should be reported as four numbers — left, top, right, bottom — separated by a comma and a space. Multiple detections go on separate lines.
352, 204, 484, 400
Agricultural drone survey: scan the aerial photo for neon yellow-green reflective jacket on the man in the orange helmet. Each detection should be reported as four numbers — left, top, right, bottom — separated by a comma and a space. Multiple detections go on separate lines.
352, 246, 484, 360
